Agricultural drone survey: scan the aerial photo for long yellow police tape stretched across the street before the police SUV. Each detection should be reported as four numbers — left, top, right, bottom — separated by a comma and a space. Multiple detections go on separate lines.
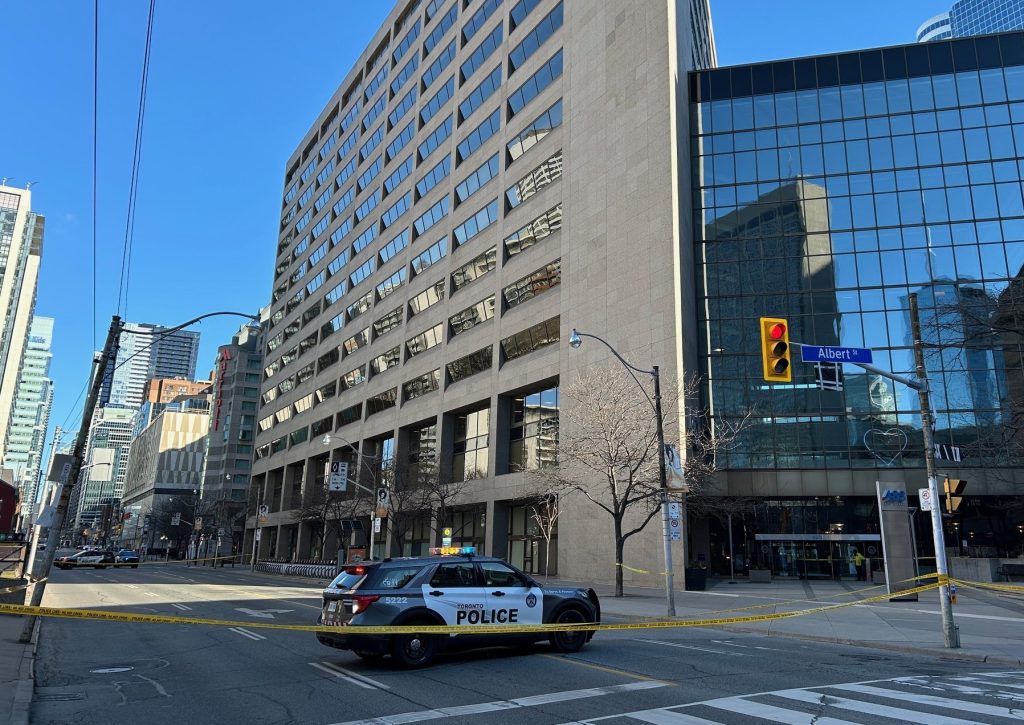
0, 574, 939, 635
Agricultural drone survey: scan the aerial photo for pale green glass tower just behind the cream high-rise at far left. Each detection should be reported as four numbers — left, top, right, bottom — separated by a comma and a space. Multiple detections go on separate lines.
4, 315, 53, 530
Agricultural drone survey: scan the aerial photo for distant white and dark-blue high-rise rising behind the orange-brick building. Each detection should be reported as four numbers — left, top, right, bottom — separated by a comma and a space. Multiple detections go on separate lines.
99, 323, 199, 410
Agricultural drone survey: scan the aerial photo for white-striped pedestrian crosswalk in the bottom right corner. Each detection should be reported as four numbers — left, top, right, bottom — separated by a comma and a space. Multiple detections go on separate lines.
581, 671, 1024, 725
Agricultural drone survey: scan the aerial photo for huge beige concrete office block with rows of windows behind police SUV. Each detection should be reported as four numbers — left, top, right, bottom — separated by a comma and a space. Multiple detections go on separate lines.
247, 0, 715, 583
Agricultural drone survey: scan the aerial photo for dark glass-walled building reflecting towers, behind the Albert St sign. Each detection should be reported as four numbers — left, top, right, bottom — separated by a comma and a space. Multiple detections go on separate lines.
690, 33, 1024, 570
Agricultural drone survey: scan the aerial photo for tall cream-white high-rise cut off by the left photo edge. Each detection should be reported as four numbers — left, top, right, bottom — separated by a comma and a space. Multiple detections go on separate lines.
0, 184, 45, 460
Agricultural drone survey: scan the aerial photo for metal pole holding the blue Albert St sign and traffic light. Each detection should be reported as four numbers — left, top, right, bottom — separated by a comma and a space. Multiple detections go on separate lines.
910, 293, 959, 649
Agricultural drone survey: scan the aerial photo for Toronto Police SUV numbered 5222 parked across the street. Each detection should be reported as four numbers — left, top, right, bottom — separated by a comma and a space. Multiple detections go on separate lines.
316, 547, 601, 668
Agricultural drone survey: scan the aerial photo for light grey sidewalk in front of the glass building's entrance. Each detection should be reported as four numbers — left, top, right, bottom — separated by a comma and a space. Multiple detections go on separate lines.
546, 578, 1024, 667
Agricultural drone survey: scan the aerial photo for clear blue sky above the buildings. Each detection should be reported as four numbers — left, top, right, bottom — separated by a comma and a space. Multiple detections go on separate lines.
0, 0, 952, 450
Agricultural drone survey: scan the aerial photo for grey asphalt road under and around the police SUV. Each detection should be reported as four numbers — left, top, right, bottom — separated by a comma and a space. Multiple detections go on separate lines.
32, 565, 1024, 725
